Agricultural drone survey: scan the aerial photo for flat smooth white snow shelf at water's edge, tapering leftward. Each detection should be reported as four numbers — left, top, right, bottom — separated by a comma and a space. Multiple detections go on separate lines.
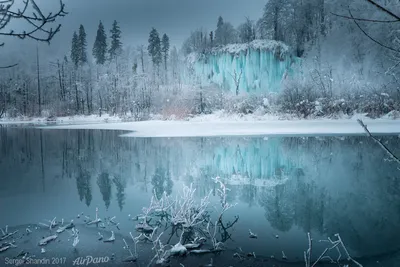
40, 119, 400, 137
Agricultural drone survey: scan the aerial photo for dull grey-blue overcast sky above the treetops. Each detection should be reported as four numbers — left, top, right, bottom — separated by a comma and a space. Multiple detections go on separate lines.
0, 0, 267, 64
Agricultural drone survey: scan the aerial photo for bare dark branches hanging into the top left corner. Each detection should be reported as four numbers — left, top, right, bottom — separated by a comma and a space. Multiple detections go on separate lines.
0, 0, 67, 68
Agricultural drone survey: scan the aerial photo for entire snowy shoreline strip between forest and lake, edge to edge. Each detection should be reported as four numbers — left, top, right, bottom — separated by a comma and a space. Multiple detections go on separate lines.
0, 114, 400, 137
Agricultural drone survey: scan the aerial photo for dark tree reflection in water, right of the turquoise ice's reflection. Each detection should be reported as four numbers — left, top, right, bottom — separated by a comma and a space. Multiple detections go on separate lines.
282, 137, 400, 254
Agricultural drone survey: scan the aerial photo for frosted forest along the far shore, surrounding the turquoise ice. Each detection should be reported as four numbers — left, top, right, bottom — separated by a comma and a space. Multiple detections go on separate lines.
0, 0, 400, 120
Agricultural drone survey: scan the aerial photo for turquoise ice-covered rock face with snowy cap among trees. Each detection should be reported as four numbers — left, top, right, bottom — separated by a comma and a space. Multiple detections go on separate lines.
183, 40, 296, 93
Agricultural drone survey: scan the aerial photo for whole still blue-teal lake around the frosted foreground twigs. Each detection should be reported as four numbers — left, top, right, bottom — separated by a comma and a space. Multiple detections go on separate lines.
0, 127, 400, 267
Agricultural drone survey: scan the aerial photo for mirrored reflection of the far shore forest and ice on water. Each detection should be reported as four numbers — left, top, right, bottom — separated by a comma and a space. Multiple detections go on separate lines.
0, 128, 400, 260
